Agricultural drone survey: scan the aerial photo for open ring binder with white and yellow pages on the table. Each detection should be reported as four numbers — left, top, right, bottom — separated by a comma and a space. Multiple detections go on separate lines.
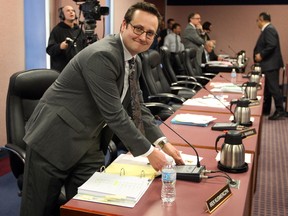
74, 154, 158, 208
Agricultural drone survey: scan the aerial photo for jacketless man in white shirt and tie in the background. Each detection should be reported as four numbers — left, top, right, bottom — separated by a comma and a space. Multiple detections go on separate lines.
163, 23, 184, 53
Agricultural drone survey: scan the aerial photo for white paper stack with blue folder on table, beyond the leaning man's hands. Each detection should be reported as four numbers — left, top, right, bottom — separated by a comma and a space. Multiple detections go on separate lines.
171, 114, 216, 127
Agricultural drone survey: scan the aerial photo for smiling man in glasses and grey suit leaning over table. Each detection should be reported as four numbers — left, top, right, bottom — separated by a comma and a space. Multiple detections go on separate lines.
21, 2, 184, 216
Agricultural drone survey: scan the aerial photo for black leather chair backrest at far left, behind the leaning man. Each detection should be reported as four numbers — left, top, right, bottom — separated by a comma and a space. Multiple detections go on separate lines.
6, 69, 59, 177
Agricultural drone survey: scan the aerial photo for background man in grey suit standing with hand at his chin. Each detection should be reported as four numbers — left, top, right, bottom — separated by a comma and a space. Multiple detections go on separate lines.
183, 13, 205, 74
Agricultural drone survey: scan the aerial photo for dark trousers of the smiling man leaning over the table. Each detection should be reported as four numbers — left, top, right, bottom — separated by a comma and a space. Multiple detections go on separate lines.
21, 145, 104, 216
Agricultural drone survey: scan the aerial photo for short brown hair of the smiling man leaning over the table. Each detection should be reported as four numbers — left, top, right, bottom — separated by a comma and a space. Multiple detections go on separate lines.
124, 2, 162, 28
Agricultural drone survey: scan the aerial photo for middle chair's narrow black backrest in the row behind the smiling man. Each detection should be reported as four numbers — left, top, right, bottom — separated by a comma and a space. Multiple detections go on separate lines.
160, 46, 177, 83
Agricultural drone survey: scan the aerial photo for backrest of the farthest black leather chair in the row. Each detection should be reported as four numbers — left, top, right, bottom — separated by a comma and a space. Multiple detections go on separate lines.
182, 48, 200, 76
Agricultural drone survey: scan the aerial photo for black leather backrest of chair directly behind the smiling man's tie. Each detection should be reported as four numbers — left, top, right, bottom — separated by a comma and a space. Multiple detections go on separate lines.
140, 49, 171, 100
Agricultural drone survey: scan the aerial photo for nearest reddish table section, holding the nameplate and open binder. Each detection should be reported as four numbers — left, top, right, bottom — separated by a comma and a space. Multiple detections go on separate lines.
61, 146, 254, 216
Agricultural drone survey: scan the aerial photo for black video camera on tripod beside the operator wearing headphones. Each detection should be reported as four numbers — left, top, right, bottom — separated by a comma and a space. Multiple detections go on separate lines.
73, 0, 109, 43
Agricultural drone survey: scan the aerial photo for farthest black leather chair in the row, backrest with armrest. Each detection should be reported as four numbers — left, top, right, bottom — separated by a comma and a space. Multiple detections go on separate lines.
182, 48, 215, 85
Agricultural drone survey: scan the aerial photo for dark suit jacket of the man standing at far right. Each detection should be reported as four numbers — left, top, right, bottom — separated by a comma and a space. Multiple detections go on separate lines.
253, 24, 284, 72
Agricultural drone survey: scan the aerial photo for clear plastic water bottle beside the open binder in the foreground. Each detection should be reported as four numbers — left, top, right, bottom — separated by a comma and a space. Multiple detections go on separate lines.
161, 163, 176, 204
